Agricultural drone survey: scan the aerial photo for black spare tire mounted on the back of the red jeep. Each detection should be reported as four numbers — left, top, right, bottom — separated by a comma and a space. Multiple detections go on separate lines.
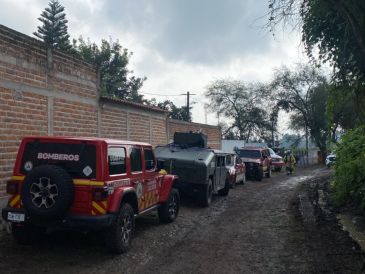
21, 165, 74, 219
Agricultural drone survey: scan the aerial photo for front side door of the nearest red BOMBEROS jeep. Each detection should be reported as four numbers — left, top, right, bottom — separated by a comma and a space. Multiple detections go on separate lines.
141, 146, 161, 209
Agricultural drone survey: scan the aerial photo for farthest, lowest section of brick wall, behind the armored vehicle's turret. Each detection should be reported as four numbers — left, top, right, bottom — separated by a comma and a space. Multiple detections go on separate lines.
167, 119, 221, 149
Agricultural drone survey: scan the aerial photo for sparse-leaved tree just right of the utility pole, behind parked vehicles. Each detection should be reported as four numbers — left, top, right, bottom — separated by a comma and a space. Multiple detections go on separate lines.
206, 80, 272, 141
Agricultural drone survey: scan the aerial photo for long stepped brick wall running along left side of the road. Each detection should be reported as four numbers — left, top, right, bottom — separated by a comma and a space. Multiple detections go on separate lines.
0, 25, 220, 208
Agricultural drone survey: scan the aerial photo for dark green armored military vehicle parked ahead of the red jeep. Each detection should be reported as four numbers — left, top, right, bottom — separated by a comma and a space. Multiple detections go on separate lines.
155, 132, 230, 206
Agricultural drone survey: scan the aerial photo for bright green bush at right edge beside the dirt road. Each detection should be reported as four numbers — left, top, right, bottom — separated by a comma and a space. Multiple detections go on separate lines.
333, 126, 365, 210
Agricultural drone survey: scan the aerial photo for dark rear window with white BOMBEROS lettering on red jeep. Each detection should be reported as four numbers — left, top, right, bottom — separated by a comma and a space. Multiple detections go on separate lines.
20, 141, 96, 178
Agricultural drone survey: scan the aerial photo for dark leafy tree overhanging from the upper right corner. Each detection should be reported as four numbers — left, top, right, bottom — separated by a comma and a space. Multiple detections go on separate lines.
269, 0, 365, 85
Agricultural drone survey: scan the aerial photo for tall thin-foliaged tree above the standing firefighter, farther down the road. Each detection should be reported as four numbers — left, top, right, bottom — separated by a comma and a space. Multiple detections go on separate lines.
271, 64, 328, 155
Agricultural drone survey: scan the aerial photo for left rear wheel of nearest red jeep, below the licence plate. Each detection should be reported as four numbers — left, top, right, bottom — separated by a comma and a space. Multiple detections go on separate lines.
11, 223, 46, 245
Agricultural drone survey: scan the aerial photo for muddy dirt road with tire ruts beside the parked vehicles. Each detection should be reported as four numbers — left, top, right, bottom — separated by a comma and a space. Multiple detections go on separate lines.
0, 168, 364, 274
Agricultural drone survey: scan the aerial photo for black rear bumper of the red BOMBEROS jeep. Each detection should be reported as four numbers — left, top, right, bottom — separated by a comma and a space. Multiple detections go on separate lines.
2, 207, 115, 230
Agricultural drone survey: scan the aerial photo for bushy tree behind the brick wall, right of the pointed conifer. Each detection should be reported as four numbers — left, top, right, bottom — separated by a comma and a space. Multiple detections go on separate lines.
73, 37, 146, 100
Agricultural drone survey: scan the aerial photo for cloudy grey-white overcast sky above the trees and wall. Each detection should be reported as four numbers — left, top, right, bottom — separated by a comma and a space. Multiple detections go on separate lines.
0, 0, 305, 130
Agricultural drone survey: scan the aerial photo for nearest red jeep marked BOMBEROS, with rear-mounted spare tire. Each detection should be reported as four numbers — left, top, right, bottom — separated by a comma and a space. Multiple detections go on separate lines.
2, 137, 180, 253
